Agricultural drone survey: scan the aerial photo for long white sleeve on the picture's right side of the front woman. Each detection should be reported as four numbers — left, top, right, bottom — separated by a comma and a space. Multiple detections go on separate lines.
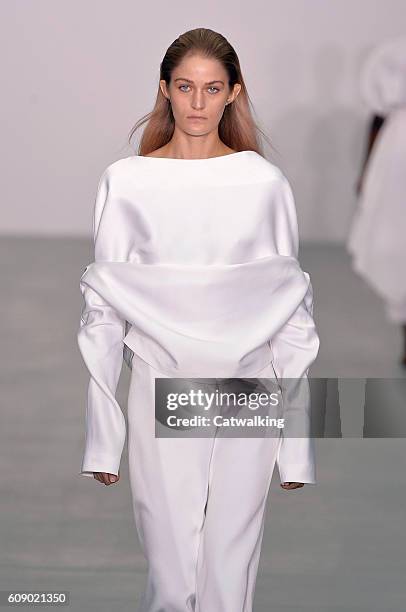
270, 176, 320, 484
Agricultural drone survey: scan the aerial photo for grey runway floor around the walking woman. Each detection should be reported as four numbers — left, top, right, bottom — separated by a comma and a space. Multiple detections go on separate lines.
0, 238, 406, 612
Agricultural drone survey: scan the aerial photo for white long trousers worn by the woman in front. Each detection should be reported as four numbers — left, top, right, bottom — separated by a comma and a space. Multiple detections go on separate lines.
128, 354, 280, 612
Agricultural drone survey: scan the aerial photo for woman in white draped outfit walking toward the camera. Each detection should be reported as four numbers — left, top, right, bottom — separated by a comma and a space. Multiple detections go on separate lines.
78, 28, 319, 612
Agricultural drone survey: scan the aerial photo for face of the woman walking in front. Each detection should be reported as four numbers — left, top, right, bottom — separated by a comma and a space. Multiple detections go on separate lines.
160, 55, 241, 135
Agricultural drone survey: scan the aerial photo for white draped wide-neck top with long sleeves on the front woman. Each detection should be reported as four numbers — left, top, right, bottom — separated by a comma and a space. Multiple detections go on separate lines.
78, 151, 319, 483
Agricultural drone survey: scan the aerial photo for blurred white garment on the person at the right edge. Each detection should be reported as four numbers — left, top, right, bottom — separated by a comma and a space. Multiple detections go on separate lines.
347, 38, 406, 323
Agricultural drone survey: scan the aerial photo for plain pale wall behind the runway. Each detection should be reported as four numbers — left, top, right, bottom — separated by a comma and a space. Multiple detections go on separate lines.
0, 0, 406, 242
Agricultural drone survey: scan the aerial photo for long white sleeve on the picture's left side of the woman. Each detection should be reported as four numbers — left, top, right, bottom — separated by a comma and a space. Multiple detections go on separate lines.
77, 170, 126, 476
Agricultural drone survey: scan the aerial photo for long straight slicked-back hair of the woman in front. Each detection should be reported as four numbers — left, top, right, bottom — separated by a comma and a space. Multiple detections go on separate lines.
128, 28, 272, 155
